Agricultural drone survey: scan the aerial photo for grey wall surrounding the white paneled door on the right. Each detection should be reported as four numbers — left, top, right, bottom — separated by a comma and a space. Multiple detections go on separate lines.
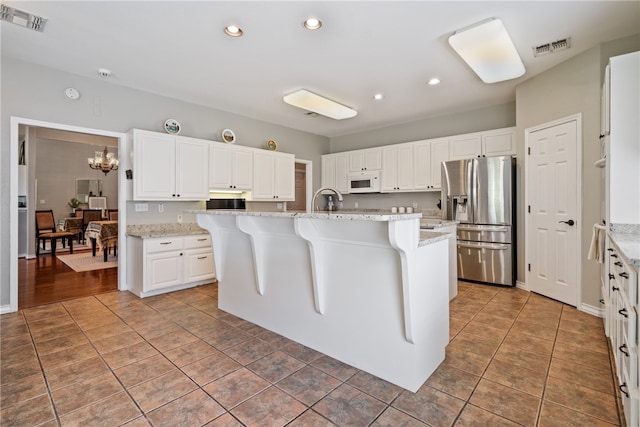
516, 36, 640, 307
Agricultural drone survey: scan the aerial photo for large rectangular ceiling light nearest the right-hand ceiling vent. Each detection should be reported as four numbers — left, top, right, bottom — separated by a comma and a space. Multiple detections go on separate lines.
449, 18, 525, 83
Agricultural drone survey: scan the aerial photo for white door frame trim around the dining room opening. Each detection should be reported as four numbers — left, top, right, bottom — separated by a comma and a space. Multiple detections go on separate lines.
7, 117, 129, 313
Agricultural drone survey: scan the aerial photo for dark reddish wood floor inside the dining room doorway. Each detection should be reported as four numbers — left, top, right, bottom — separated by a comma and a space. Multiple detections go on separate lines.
18, 249, 118, 309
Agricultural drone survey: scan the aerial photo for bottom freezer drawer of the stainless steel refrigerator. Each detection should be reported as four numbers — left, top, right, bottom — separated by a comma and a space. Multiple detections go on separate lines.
458, 240, 514, 286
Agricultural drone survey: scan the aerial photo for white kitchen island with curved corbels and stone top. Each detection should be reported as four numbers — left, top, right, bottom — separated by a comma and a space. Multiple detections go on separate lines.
189, 210, 450, 392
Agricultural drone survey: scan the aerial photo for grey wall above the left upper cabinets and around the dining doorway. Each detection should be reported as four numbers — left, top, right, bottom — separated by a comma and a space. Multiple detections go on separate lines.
0, 56, 329, 305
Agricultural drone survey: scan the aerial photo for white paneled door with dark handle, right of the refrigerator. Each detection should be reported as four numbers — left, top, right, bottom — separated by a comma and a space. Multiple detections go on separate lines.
525, 119, 580, 306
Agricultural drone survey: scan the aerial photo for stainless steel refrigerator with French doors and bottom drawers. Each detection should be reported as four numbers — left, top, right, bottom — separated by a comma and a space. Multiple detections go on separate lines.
442, 156, 516, 286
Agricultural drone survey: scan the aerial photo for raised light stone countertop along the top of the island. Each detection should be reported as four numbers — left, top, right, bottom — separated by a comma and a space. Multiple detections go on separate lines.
185, 209, 422, 221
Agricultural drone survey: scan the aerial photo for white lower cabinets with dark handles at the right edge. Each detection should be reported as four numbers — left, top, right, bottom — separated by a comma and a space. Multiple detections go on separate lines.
603, 242, 640, 426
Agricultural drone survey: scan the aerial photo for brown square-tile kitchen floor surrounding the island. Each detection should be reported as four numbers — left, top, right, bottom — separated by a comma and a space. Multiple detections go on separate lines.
0, 282, 620, 427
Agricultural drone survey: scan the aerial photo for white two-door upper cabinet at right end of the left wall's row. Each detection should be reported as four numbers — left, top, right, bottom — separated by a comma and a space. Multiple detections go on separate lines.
252, 150, 295, 201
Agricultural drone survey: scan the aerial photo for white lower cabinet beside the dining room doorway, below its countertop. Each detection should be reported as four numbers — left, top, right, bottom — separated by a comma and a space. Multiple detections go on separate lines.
127, 234, 215, 298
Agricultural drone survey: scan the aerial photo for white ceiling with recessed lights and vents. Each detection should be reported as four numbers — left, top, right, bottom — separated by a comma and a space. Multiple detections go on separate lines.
1, 0, 640, 137
